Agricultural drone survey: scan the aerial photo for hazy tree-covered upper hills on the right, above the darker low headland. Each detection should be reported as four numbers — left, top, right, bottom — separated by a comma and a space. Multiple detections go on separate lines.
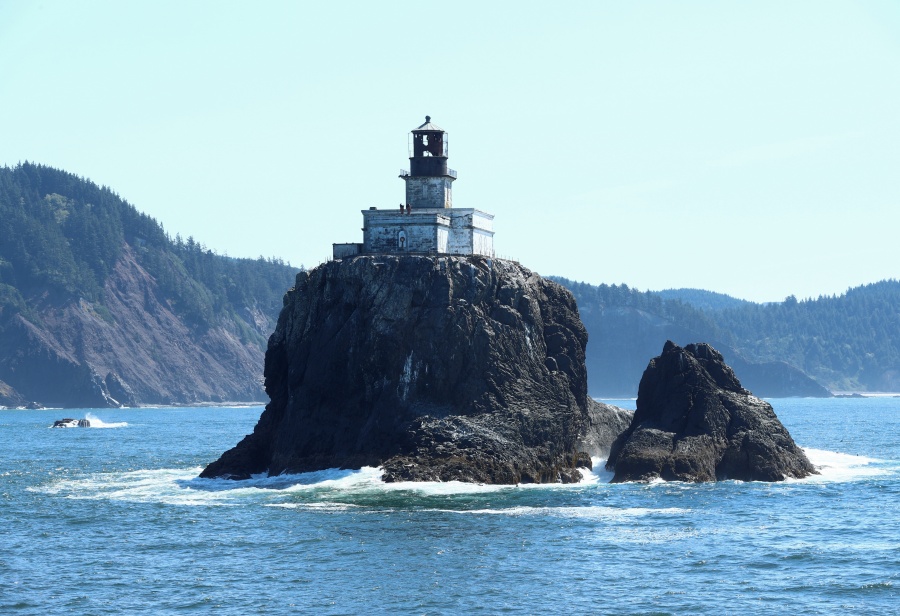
556, 278, 900, 391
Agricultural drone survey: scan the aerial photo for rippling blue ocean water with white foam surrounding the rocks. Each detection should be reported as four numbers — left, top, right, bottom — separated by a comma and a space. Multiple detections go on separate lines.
0, 397, 900, 615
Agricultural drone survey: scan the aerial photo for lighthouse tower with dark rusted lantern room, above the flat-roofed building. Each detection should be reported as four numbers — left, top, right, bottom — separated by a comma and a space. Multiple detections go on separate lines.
400, 116, 456, 209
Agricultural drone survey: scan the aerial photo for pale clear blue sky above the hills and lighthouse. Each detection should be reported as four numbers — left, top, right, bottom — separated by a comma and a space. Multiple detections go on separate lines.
0, 0, 900, 301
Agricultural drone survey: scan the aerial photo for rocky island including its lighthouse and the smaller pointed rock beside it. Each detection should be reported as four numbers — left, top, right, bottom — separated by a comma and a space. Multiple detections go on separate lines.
201, 116, 814, 484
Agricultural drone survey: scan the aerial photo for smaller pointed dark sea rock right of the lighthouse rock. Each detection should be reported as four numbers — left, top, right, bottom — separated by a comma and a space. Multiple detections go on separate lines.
607, 341, 816, 482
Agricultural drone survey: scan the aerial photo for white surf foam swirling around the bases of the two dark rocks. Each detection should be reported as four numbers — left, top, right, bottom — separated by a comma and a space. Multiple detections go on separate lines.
28, 448, 898, 510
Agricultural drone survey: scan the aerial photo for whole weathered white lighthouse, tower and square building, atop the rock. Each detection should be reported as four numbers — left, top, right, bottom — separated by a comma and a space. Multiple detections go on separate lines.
333, 116, 494, 259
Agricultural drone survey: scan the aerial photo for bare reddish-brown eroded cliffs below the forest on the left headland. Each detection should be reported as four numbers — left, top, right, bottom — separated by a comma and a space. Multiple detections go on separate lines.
0, 246, 271, 407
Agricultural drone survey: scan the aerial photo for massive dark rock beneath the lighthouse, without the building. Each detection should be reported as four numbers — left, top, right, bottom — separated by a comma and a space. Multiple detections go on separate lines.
202, 256, 630, 483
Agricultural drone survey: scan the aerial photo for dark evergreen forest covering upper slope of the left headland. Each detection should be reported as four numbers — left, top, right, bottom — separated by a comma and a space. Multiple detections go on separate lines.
0, 162, 297, 344
